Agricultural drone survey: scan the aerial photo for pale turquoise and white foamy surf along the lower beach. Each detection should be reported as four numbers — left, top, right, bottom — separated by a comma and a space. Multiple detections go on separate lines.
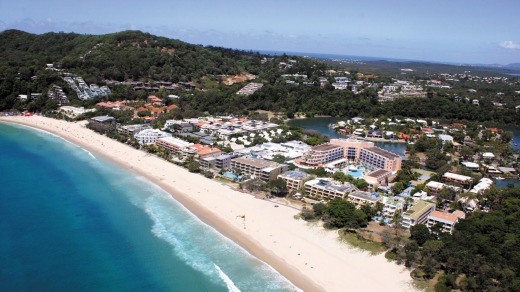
140, 192, 300, 291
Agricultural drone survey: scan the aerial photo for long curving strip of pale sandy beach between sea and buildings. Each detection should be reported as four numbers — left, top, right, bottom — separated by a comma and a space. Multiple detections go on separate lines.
0, 116, 414, 291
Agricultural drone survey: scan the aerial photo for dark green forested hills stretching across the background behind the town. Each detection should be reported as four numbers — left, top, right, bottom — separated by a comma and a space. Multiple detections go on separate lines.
0, 30, 520, 124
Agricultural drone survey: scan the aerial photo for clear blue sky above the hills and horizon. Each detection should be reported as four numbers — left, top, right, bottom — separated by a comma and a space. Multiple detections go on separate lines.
0, 0, 520, 65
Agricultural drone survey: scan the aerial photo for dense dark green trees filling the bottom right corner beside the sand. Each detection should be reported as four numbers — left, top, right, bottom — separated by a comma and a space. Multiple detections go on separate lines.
387, 188, 520, 291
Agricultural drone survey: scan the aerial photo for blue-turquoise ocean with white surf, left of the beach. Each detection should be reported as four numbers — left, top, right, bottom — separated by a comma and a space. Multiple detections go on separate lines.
0, 123, 298, 291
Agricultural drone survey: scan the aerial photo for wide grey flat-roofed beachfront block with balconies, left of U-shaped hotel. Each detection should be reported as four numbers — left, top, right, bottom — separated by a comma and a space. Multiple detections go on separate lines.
231, 157, 288, 181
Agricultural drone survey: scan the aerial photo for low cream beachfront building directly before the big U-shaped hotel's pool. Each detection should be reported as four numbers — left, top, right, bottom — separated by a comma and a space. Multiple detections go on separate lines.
305, 178, 358, 200
